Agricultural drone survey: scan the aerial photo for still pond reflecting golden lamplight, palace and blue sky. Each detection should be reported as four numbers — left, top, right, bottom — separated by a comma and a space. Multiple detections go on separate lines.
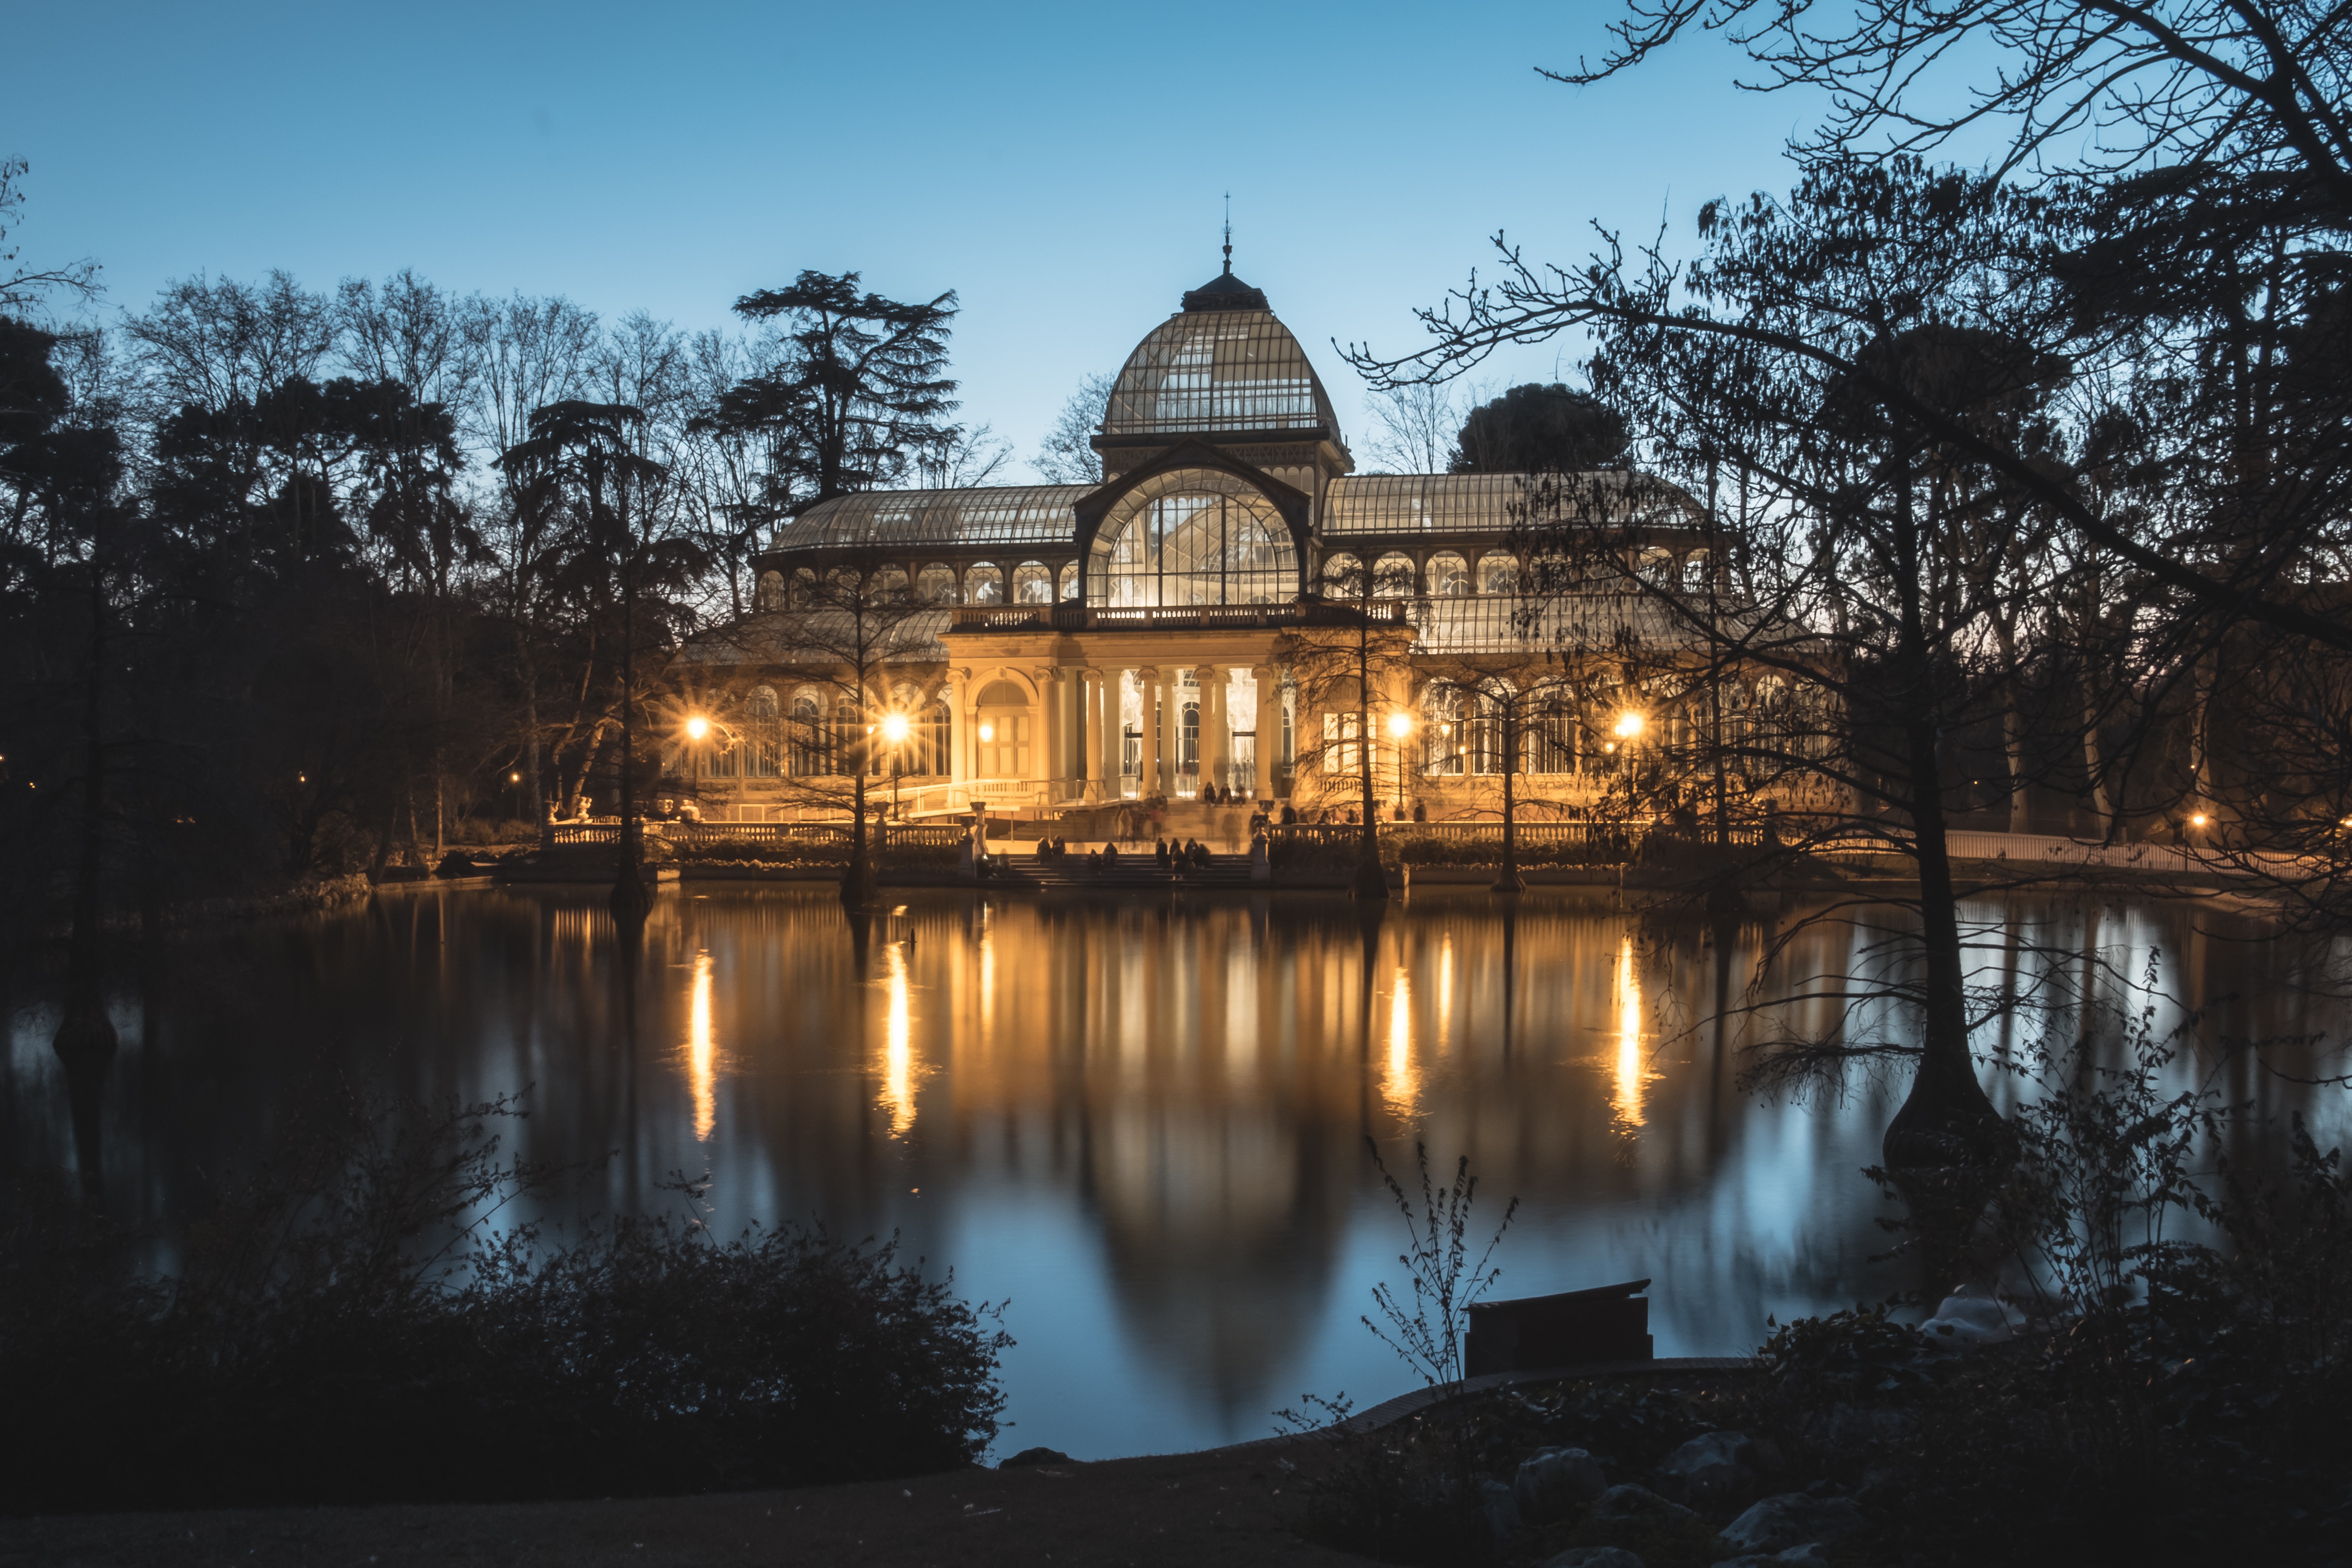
5, 884, 2343, 1457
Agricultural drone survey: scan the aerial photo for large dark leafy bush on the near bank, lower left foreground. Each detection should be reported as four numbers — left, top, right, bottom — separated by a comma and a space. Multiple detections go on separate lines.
0, 1105, 1009, 1514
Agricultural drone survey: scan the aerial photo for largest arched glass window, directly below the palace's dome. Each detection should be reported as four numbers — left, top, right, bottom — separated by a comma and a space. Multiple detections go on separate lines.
1087, 468, 1298, 609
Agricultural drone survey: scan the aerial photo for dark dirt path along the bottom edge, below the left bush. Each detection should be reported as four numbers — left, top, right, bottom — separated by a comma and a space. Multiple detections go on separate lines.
0, 1446, 1364, 1568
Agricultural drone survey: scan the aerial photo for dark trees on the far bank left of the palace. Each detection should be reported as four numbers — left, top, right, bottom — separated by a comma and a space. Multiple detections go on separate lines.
0, 228, 1007, 919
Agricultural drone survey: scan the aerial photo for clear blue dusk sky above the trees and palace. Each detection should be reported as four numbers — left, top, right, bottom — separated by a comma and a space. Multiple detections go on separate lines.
0, 0, 1816, 472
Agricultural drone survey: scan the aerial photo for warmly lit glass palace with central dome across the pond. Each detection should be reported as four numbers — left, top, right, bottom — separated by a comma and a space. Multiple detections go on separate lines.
684, 266, 1714, 820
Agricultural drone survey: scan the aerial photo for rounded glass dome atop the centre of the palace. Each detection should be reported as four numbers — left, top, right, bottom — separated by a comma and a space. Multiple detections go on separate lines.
1103, 270, 1338, 442
